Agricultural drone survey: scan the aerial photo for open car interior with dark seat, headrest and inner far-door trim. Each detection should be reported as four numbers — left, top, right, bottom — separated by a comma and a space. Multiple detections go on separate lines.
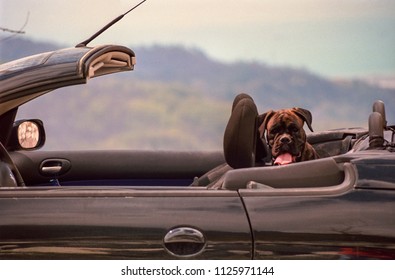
7, 94, 390, 190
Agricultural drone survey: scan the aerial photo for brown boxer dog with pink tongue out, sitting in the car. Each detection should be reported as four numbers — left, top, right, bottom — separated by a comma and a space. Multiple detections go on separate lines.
258, 108, 318, 165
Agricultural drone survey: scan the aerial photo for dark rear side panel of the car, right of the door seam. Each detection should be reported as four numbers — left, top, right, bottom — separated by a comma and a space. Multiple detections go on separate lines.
243, 190, 395, 259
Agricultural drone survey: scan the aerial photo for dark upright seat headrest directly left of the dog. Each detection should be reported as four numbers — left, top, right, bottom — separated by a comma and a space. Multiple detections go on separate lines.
224, 93, 266, 168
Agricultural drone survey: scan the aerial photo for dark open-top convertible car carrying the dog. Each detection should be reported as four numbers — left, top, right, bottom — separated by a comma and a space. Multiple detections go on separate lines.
0, 45, 395, 259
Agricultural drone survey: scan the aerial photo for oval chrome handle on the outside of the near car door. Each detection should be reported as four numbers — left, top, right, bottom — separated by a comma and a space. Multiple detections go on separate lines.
163, 227, 206, 257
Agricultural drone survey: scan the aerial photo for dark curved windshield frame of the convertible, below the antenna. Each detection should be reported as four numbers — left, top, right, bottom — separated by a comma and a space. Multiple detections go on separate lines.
0, 45, 135, 115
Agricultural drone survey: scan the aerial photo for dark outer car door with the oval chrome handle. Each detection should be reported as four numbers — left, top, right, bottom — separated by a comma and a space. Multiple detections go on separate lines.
0, 186, 253, 259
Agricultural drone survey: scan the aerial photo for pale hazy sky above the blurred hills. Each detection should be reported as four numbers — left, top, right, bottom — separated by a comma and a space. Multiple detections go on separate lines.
0, 0, 395, 78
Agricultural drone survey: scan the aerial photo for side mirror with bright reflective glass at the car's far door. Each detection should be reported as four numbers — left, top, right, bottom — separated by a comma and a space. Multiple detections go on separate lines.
7, 119, 45, 150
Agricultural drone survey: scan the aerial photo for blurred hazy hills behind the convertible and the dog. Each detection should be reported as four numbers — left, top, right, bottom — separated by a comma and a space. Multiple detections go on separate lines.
0, 37, 395, 150
